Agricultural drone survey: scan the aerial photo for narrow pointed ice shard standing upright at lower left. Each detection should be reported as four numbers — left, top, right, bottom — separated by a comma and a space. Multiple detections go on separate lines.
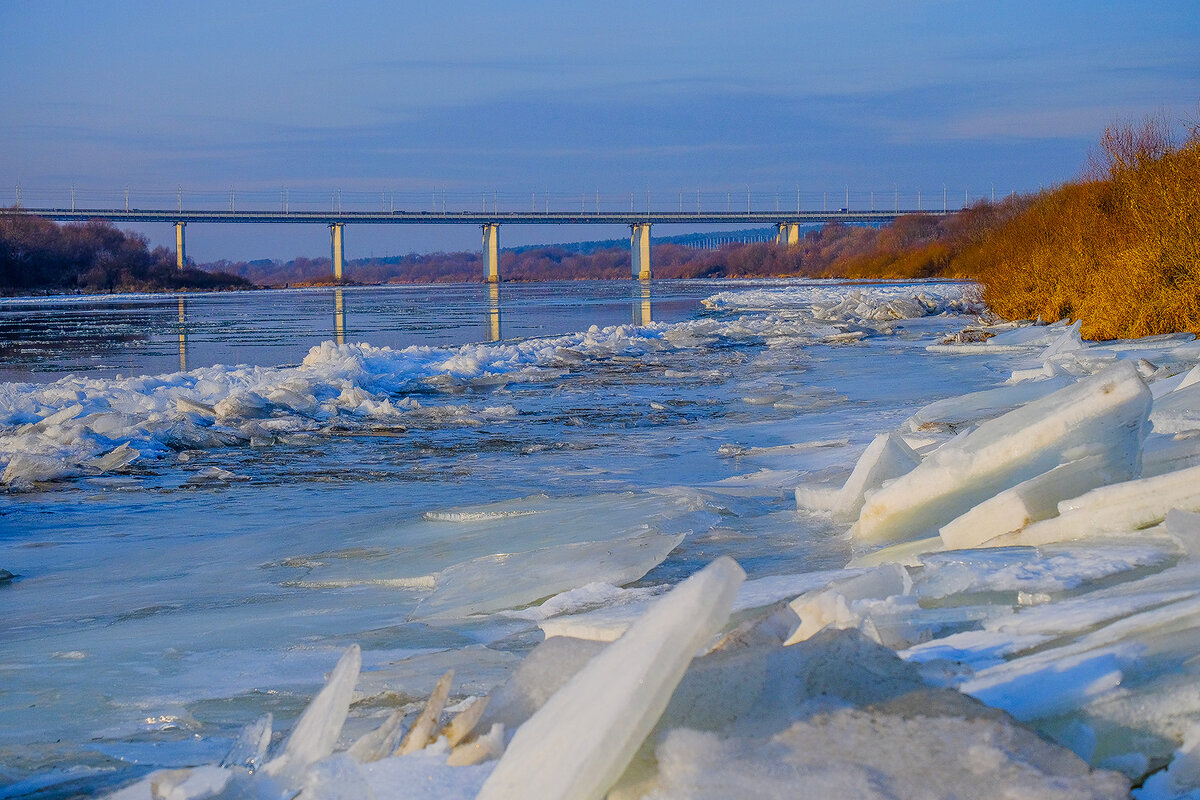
263, 644, 362, 776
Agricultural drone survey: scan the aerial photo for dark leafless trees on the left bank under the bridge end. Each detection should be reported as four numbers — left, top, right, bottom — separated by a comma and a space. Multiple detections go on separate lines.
0, 210, 253, 294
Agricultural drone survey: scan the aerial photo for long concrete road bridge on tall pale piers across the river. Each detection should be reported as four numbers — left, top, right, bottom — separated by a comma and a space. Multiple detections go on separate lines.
7, 205, 956, 283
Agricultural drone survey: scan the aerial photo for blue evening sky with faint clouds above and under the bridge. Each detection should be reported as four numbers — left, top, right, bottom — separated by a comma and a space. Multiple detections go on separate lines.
0, 0, 1200, 261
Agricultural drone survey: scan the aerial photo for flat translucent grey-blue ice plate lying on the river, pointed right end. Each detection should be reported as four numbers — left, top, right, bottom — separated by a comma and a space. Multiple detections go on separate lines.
413, 531, 685, 620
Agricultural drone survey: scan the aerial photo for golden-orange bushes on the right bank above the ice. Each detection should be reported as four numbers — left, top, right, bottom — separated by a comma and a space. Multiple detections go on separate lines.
953, 120, 1200, 339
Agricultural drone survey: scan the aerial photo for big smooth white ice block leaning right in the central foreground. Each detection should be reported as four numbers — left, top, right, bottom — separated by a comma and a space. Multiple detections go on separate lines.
478, 558, 745, 800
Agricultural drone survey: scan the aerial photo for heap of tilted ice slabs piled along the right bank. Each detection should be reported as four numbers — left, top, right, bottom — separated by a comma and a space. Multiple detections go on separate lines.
792, 325, 1200, 798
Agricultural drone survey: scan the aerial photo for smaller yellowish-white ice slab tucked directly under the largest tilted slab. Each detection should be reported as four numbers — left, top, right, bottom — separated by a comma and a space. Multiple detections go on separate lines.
938, 456, 1128, 549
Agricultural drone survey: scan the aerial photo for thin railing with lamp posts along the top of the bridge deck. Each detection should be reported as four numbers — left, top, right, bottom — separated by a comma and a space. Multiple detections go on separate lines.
7, 186, 1012, 213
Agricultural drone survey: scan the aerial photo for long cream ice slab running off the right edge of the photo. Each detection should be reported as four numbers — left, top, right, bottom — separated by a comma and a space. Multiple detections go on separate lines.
989, 467, 1200, 545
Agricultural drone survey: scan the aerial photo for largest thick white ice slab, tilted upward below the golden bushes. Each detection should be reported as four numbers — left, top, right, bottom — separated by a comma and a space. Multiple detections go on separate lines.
852, 362, 1151, 542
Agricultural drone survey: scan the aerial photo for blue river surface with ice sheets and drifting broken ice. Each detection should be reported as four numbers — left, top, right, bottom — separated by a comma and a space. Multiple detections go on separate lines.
9, 282, 1200, 798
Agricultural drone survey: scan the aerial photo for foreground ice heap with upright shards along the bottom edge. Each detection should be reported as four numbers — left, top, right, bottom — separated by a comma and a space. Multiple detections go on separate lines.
112, 559, 1128, 800
